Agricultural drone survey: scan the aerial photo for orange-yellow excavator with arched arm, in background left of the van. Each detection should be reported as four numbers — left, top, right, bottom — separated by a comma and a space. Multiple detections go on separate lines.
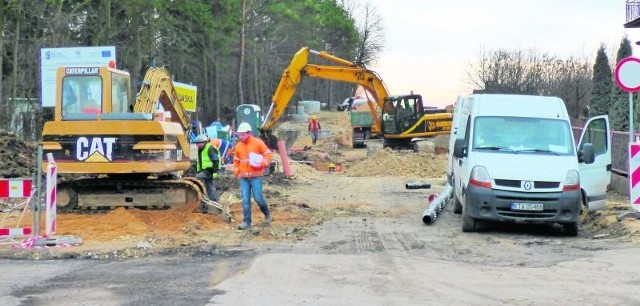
261, 47, 453, 148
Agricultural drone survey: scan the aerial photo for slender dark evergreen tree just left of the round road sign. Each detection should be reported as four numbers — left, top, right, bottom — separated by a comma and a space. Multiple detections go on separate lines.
589, 44, 613, 117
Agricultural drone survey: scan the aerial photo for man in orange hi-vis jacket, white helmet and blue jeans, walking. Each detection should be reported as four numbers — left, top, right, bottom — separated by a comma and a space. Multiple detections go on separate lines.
233, 122, 271, 230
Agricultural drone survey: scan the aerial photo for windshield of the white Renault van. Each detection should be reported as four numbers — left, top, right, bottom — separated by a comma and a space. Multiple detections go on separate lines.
473, 117, 575, 155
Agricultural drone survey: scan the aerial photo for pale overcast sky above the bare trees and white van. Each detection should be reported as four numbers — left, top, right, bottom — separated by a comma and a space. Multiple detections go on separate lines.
364, 0, 640, 106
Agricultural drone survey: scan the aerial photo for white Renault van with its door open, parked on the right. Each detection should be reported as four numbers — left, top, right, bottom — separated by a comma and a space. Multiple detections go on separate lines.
447, 94, 611, 236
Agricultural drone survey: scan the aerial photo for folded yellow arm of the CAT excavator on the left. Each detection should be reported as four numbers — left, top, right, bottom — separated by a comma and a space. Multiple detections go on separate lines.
133, 67, 191, 132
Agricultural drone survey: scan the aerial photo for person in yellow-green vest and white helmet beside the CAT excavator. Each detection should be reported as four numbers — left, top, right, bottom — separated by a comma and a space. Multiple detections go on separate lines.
195, 134, 220, 202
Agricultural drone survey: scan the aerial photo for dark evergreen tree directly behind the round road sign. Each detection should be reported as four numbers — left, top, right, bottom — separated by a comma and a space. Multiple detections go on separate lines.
609, 36, 635, 131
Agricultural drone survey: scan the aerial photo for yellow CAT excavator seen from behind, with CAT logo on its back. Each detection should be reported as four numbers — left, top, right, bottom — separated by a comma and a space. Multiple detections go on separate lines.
42, 67, 228, 217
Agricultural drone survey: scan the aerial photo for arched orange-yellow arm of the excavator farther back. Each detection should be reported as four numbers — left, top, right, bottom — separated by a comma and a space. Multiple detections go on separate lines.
261, 47, 389, 133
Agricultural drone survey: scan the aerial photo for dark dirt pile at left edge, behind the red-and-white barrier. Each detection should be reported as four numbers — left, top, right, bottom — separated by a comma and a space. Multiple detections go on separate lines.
0, 130, 37, 178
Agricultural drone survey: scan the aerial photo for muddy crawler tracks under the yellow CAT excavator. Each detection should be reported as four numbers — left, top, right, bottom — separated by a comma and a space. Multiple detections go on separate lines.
56, 177, 229, 219
